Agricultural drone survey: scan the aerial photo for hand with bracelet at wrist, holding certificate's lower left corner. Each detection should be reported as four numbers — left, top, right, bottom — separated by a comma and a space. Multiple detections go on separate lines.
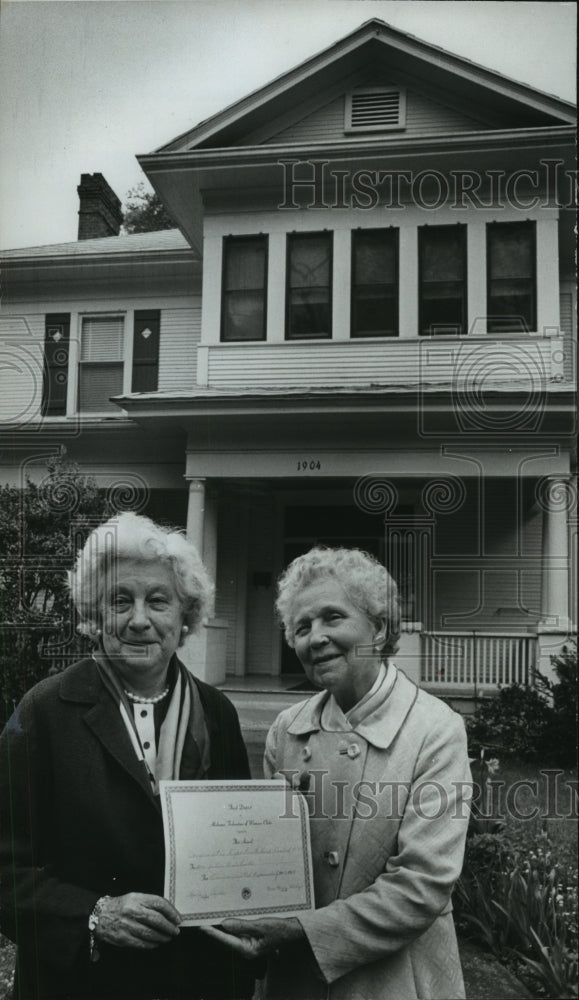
95, 892, 181, 949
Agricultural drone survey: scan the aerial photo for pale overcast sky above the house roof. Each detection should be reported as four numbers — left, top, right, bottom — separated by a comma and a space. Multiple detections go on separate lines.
0, 0, 576, 248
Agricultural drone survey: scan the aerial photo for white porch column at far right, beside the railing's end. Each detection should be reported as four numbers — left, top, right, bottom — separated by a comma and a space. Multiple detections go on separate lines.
541, 476, 572, 630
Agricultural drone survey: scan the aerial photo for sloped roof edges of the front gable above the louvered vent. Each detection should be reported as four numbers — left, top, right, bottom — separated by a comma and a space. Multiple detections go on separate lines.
157, 18, 575, 153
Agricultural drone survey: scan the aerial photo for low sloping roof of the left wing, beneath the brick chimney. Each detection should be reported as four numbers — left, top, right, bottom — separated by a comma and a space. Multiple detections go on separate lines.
0, 229, 194, 261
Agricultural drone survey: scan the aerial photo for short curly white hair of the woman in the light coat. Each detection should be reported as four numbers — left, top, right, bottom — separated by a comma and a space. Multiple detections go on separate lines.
276, 545, 400, 655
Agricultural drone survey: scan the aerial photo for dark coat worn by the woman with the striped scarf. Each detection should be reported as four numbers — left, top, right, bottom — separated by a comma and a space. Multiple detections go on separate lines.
0, 659, 253, 1000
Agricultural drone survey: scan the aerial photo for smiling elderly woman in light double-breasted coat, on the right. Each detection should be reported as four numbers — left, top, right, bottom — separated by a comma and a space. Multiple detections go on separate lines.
211, 547, 470, 1000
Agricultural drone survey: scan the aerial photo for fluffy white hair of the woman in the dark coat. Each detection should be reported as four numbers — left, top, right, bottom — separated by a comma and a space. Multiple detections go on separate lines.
68, 512, 214, 635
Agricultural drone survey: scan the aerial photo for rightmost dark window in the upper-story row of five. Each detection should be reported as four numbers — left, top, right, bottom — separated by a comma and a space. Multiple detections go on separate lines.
487, 222, 537, 333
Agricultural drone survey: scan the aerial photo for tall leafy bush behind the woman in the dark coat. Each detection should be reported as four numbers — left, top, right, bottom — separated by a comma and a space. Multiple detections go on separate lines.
0, 458, 108, 721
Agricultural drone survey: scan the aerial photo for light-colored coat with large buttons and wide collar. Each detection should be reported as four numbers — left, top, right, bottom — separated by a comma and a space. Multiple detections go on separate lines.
265, 671, 470, 1000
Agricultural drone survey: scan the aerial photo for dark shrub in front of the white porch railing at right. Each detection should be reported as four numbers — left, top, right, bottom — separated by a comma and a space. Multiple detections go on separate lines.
467, 644, 577, 767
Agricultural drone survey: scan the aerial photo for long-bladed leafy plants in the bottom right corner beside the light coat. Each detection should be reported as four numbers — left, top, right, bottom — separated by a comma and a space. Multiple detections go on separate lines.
454, 829, 579, 998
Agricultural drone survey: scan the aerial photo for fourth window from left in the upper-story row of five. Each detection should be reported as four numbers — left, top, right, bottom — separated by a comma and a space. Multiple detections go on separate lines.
418, 225, 467, 336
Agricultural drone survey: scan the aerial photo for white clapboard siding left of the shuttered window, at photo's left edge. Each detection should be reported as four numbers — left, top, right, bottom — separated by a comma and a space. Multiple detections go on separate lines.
0, 314, 44, 425
